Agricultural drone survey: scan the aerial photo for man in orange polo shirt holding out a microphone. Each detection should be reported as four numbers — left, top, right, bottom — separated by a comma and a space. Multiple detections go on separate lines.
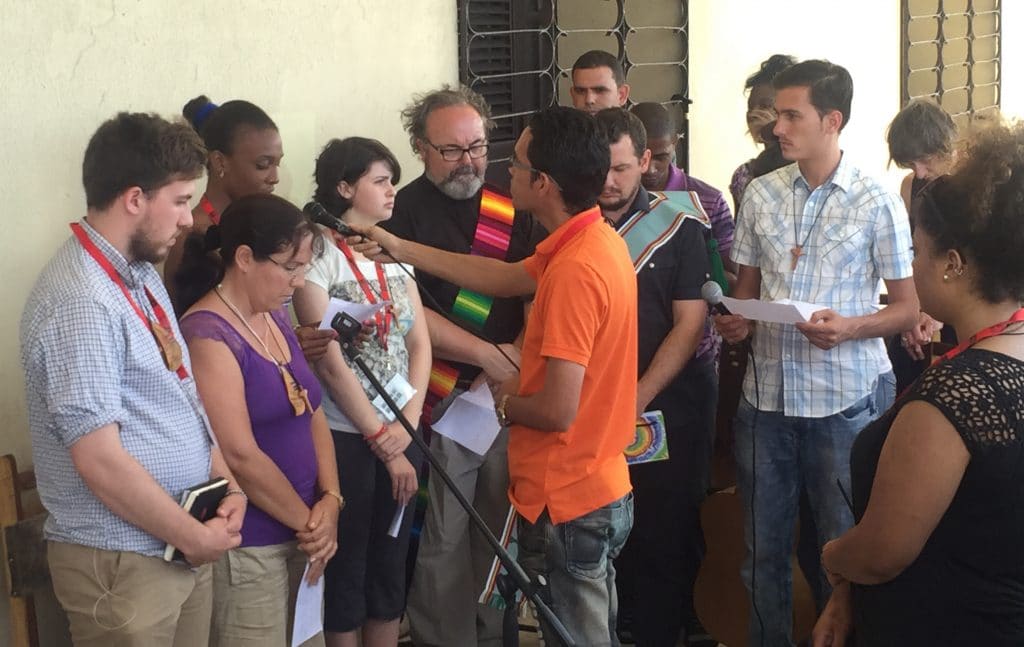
356, 107, 637, 646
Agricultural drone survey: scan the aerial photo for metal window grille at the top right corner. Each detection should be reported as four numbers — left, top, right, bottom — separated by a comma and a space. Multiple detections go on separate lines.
900, 0, 1001, 126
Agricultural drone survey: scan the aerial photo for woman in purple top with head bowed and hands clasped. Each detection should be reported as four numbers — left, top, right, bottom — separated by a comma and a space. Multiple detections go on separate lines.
176, 193, 344, 647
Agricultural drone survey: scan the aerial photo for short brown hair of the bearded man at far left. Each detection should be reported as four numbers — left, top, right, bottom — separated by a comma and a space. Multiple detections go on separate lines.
82, 113, 206, 209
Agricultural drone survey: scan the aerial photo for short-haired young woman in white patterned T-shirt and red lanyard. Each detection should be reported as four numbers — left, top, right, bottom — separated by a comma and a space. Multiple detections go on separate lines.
295, 137, 430, 647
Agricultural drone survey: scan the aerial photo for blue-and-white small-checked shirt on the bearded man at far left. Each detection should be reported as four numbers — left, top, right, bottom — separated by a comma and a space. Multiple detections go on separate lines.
22, 221, 210, 556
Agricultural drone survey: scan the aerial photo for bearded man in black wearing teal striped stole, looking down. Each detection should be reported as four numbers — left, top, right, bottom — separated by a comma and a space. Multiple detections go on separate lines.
596, 107, 718, 645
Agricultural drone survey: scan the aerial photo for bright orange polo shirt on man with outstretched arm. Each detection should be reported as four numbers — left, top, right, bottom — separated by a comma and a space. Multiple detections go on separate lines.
508, 207, 637, 523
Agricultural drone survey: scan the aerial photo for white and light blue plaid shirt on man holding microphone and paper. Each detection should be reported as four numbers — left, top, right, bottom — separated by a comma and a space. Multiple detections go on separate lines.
732, 156, 912, 418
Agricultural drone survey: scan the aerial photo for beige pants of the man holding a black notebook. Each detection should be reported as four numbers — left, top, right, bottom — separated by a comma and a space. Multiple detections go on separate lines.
47, 542, 212, 647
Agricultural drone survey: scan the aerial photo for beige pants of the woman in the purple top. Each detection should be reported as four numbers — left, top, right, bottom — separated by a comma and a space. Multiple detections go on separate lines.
210, 542, 324, 647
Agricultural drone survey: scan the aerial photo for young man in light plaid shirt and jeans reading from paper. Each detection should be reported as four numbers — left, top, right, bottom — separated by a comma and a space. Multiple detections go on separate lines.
716, 60, 919, 645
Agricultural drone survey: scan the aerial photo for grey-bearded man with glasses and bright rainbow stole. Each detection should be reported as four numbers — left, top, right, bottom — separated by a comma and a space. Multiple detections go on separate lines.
383, 86, 546, 647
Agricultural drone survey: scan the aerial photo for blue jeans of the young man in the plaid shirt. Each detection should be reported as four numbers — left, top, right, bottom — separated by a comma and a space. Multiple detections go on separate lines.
735, 373, 895, 647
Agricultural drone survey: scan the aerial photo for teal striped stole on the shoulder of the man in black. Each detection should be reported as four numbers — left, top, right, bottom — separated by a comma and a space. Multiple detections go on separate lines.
618, 191, 711, 273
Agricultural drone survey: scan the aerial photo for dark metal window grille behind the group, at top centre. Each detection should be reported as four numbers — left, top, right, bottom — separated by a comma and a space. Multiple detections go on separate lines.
458, 0, 689, 184
